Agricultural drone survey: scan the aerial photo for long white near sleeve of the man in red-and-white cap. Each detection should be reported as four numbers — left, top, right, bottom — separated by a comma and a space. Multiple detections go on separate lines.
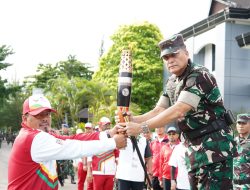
31, 132, 116, 162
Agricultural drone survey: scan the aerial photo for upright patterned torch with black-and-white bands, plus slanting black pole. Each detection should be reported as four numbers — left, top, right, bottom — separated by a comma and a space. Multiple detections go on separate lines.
117, 50, 152, 188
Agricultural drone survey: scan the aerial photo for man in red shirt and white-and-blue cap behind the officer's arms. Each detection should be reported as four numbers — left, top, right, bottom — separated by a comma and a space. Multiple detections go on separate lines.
159, 126, 180, 190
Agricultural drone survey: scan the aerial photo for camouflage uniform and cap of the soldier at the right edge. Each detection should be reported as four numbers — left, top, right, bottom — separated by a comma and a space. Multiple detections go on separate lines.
233, 114, 250, 190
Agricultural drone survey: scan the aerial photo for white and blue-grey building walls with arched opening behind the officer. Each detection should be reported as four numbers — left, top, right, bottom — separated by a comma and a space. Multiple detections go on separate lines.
186, 22, 250, 112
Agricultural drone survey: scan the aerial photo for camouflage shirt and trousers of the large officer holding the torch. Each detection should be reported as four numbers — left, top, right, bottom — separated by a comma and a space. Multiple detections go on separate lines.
163, 60, 237, 190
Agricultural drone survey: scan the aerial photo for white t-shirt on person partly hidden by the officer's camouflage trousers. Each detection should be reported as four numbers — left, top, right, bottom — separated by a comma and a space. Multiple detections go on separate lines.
168, 142, 190, 189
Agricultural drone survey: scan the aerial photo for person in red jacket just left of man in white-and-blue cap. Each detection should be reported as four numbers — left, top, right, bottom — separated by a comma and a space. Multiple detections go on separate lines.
150, 127, 168, 190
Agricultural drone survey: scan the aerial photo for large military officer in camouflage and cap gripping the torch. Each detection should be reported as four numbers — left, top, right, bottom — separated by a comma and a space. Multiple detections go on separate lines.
120, 34, 237, 189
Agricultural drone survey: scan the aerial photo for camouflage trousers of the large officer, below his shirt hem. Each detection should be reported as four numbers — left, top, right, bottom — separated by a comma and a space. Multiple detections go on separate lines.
188, 159, 233, 190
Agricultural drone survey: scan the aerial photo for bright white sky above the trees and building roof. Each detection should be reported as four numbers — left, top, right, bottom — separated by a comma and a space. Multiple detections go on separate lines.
0, 0, 211, 82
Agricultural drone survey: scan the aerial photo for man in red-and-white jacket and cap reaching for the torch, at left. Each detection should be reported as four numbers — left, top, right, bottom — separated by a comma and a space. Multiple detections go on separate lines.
8, 94, 127, 190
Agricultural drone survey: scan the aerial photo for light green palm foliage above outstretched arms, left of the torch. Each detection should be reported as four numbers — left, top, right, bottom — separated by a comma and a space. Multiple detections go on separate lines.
46, 77, 114, 126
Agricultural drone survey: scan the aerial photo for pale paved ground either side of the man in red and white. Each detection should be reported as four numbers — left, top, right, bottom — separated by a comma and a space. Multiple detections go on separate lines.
0, 141, 77, 190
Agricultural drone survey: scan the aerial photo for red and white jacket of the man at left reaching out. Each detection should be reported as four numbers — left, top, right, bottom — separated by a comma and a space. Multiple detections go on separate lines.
8, 124, 116, 190
